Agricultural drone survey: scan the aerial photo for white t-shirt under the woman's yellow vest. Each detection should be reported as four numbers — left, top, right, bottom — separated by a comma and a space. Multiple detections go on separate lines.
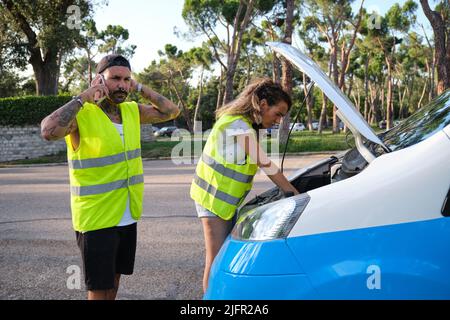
219, 119, 253, 164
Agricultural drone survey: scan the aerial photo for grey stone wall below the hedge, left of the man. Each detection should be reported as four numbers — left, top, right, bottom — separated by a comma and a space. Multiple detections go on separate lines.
0, 126, 66, 162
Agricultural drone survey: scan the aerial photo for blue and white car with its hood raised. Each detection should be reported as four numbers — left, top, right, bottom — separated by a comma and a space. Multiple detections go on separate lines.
204, 43, 450, 299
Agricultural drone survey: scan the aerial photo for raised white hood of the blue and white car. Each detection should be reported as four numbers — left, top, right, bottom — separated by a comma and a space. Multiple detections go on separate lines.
267, 42, 389, 162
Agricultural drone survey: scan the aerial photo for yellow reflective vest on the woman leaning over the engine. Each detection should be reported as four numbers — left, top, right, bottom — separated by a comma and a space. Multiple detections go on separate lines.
191, 115, 258, 220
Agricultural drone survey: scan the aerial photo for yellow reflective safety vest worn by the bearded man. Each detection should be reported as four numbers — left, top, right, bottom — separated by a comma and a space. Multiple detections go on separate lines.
66, 102, 144, 232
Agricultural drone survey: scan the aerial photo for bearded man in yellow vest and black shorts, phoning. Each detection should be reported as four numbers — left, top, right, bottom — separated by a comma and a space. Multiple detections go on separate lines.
41, 55, 180, 300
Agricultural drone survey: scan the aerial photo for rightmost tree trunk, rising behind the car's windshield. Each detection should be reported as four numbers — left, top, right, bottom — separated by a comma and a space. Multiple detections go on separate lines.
420, 0, 450, 94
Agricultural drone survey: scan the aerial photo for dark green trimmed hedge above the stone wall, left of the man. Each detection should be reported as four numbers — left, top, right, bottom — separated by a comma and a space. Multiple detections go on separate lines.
0, 95, 72, 126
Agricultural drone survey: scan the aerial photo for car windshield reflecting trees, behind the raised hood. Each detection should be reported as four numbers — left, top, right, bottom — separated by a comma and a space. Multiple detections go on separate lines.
379, 89, 450, 151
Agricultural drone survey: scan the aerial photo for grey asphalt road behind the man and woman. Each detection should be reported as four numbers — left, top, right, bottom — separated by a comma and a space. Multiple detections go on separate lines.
0, 154, 327, 300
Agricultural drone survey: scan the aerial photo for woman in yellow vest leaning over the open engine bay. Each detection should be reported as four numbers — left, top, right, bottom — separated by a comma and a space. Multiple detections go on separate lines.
190, 78, 298, 292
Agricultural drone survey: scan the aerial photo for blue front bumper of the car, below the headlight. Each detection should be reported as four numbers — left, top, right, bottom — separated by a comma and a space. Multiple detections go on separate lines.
204, 237, 317, 300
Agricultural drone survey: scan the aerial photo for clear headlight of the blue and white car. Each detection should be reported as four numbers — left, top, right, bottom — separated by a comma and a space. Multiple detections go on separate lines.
231, 193, 310, 240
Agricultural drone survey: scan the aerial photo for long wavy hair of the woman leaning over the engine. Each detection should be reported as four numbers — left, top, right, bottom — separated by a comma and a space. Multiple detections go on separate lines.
216, 78, 292, 124
